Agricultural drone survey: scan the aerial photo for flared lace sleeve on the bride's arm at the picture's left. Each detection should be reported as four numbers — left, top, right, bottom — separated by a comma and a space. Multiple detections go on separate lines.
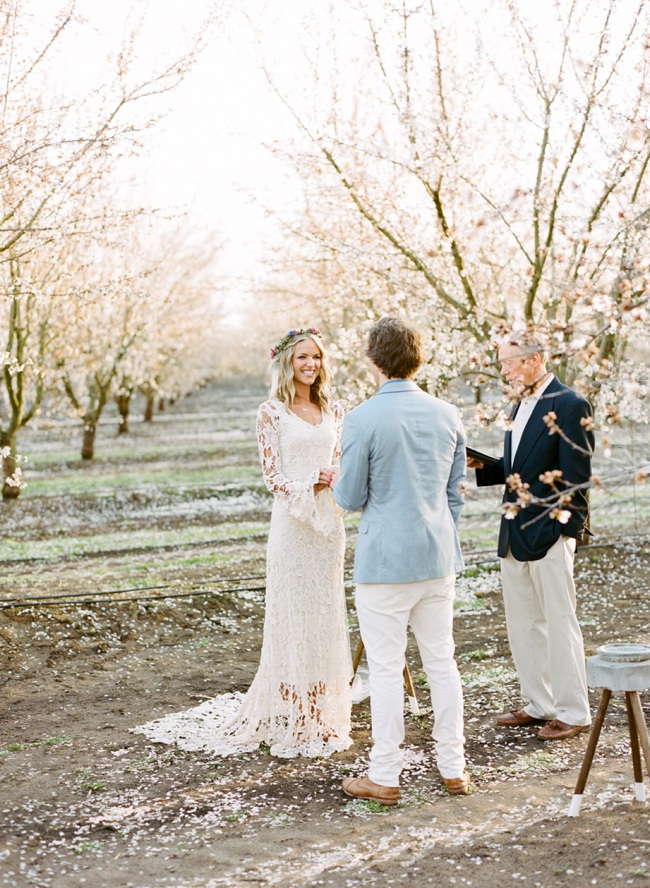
257, 401, 320, 525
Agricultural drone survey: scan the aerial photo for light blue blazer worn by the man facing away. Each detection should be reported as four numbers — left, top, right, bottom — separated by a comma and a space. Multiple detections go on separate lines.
334, 379, 467, 583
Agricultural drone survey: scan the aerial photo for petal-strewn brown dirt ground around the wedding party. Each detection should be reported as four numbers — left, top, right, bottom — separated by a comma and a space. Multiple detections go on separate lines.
0, 378, 650, 888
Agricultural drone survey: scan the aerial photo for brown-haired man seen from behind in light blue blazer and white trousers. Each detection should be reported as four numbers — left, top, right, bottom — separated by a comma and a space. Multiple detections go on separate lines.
334, 318, 470, 805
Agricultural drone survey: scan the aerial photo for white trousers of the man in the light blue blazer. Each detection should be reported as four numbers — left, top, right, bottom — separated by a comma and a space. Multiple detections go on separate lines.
355, 575, 465, 786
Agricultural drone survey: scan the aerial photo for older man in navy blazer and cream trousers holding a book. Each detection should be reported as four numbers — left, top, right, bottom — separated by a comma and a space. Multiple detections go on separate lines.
467, 330, 594, 740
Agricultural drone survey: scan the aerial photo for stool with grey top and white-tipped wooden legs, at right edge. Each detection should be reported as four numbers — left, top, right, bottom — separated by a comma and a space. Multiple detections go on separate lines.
567, 656, 650, 817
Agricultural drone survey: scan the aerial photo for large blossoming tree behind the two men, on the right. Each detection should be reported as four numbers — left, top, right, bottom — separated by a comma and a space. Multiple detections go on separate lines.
260, 0, 650, 418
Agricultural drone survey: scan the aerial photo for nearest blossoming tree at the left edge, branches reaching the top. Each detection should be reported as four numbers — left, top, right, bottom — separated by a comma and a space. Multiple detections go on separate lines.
0, 0, 218, 498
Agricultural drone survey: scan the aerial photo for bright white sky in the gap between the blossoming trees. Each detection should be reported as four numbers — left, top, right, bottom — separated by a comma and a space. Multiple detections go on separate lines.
126, 0, 382, 318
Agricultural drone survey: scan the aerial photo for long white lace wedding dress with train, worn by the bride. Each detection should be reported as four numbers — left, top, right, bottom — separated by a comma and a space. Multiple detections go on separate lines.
134, 400, 352, 758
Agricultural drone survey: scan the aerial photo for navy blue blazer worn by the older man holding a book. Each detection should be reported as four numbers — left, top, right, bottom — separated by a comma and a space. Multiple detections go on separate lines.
476, 377, 594, 561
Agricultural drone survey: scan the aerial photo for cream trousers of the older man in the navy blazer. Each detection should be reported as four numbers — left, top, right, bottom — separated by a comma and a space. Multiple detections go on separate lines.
501, 537, 591, 725
